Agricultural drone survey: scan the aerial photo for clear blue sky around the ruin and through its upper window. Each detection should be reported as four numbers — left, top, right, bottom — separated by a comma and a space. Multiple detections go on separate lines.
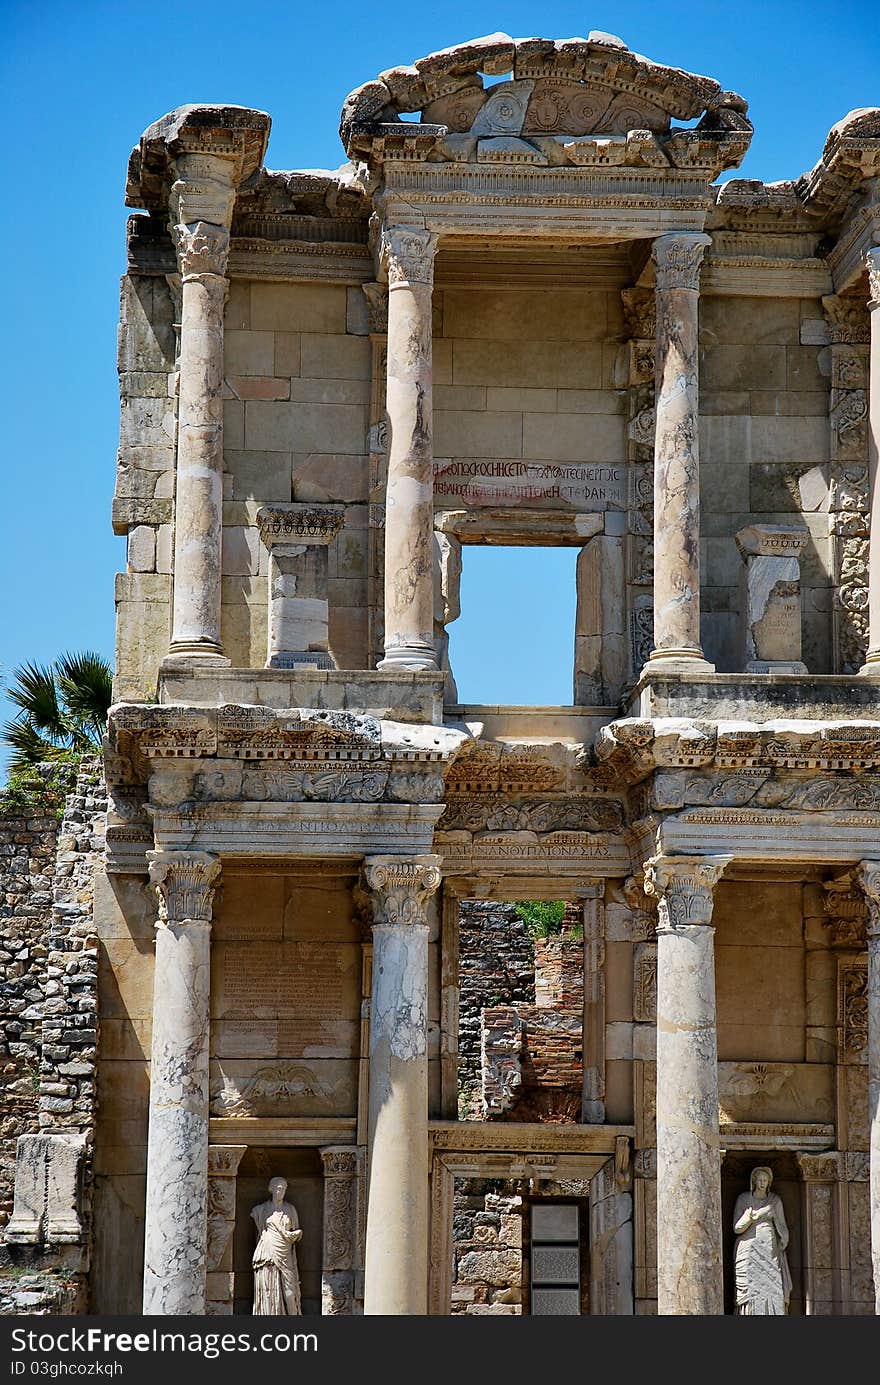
0, 0, 880, 747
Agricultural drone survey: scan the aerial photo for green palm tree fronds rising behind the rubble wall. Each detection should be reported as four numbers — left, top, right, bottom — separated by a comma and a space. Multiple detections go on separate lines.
1, 650, 112, 773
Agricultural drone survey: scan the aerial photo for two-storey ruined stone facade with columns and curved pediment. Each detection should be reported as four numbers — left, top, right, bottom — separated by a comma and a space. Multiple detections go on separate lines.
7, 33, 880, 1316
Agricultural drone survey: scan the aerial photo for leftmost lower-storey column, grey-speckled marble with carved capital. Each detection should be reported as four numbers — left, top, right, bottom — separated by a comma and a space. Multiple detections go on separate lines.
144, 852, 220, 1316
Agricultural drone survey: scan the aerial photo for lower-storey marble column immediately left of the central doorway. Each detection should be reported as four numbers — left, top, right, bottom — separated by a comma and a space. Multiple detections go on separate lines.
363, 856, 441, 1316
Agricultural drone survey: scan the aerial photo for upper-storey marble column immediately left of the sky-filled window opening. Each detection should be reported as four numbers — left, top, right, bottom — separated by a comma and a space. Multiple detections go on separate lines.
378, 226, 437, 669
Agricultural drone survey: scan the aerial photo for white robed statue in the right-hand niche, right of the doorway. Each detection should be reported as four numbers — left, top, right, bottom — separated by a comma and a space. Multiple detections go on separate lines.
733, 1165, 791, 1317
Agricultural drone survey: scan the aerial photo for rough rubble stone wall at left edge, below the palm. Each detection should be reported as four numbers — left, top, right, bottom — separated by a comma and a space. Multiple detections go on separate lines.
0, 760, 107, 1314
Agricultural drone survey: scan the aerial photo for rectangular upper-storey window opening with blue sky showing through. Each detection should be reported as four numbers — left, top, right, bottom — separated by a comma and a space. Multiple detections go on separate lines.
449, 544, 581, 706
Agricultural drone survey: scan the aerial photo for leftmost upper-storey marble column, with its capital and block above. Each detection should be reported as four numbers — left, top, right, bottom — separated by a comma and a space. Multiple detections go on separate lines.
168, 154, 236, 665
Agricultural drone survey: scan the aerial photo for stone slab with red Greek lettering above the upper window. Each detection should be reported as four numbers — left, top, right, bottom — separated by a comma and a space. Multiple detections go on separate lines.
434, 457, 626, 511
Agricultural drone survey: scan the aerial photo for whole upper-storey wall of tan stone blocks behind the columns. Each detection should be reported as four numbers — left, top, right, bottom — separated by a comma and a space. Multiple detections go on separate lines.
114, 274, 834, 702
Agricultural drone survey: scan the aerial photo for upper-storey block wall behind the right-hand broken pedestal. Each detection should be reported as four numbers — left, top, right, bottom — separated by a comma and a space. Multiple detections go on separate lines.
700, 294, 833, 673
